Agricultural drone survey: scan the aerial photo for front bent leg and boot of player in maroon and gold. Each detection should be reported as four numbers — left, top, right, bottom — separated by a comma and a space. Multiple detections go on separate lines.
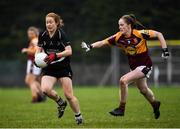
110, 69, 145, 116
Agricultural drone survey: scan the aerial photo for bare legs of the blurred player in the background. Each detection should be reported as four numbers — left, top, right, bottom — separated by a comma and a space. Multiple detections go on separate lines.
25, 74, 43, 102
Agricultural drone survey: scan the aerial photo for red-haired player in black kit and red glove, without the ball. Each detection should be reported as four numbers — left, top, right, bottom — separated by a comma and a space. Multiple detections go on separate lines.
37, 13, 83, 124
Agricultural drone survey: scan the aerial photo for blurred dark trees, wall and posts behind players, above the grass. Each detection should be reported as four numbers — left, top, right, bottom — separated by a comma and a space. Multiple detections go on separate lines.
0, 0, 180, 87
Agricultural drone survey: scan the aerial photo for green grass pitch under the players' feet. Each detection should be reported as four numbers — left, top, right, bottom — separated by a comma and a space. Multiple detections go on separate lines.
0, 87, 180, 128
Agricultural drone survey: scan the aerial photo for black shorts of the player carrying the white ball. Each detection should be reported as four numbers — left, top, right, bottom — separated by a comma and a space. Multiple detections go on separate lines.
42, 66, 73, 79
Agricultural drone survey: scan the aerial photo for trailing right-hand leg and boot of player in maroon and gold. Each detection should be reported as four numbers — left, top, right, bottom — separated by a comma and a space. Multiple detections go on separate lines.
136, 78, 160, 119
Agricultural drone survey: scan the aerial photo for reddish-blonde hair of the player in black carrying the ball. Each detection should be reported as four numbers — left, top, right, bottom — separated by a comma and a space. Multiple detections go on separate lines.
46, 12, 64, 28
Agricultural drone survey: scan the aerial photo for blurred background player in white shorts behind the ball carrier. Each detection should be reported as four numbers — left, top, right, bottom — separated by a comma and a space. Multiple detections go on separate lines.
22, 27, 45, 103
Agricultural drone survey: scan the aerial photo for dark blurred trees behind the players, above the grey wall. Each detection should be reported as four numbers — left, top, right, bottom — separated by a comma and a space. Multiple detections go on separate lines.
0, 0, 180, 62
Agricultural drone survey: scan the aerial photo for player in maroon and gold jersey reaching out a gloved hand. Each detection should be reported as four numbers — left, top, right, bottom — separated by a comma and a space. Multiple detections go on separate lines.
81, 15, 169, 119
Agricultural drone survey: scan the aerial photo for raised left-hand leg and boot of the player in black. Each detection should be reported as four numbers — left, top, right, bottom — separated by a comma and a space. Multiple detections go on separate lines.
41, 76, 67, 118
